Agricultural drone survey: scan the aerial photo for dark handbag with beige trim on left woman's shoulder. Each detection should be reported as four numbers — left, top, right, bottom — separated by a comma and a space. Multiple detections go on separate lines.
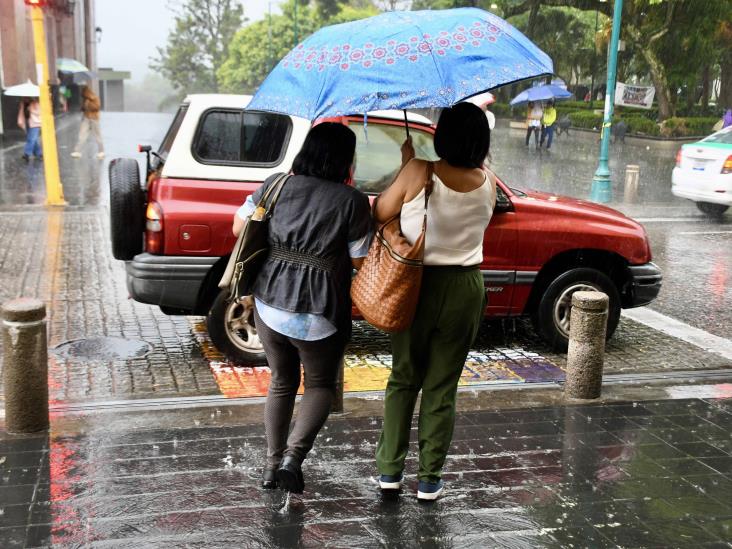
219, 173, 289, 301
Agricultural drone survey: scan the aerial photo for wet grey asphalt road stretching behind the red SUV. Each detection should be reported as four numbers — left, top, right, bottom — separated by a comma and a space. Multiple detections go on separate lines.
0, 113, 732, 338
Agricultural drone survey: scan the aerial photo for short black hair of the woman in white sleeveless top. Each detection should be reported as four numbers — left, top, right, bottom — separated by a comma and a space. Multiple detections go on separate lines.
435, 103, 491, 168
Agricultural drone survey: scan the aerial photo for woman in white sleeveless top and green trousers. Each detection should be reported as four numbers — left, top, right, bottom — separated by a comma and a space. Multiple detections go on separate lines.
375, 103, 496, 500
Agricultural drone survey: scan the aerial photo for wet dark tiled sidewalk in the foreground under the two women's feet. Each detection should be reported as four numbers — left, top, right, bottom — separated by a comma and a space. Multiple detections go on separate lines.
0, 392, 732, 548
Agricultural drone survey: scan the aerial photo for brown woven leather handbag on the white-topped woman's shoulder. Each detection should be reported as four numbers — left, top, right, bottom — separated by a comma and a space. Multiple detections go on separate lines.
351, 162, 433, 332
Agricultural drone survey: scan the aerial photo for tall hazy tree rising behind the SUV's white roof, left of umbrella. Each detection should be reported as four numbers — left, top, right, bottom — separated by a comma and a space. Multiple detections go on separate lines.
150, 0, 244, 93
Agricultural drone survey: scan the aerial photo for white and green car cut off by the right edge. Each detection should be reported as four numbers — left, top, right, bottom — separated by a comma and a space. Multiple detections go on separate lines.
671, 126, 732, 217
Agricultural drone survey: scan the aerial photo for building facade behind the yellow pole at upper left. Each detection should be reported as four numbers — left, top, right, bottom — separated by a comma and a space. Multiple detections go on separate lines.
0, 0, 97, 133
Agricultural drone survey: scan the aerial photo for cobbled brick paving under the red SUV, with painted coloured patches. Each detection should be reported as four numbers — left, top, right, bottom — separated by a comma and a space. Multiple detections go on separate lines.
0, 207, 730, 402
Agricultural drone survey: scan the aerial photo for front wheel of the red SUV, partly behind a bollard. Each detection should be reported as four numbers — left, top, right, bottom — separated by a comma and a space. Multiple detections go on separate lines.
533, 267, 620, 352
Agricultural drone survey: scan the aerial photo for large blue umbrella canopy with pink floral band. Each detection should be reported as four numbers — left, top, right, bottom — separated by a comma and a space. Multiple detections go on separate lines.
248, 8, 554, 120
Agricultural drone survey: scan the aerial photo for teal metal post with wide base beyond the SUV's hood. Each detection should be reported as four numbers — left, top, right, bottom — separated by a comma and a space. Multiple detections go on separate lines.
590, 0, 623, 202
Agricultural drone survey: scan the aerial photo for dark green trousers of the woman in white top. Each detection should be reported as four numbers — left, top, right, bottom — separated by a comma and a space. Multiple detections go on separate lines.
376, 267, 486, 482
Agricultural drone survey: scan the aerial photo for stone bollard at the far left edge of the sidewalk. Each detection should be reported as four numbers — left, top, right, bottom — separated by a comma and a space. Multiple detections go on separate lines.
1, 298, 48, 433
